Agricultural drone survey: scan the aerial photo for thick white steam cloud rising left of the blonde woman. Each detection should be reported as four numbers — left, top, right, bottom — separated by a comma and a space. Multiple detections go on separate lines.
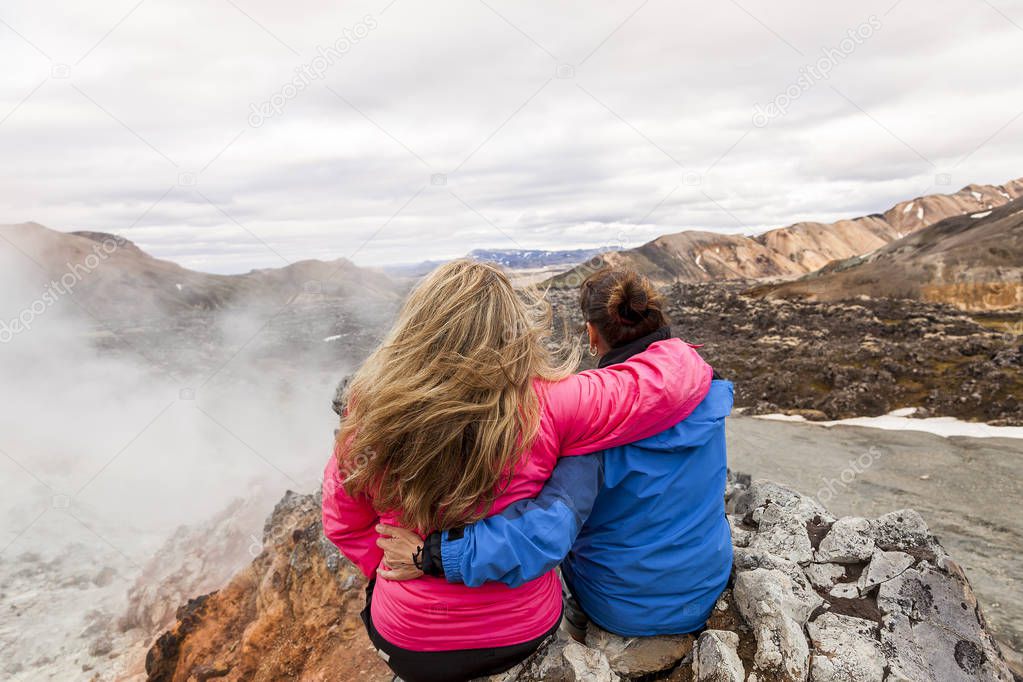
0, 249, 391, 679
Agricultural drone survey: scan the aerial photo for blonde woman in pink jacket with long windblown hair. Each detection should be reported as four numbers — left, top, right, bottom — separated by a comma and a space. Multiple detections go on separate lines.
323, 260, 713, 682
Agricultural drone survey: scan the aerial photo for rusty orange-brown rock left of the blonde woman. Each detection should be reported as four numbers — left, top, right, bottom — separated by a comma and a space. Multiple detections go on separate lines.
145, 492, 393, 682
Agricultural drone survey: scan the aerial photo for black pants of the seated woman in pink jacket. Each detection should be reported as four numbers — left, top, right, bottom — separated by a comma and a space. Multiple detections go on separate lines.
362, 581, 561, 682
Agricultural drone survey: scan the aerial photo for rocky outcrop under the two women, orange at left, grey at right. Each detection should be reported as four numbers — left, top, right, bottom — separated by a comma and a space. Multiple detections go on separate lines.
145, 482, 1013, 682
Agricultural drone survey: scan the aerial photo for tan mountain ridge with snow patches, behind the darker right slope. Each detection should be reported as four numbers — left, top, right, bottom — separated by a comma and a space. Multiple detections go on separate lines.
551, 179, 1023, 286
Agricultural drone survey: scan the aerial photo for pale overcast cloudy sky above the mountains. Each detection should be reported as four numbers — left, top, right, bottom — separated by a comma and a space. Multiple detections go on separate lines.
0, 0, 1023, 272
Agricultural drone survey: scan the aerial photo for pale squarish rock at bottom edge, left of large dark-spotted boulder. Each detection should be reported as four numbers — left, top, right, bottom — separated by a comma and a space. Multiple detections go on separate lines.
806, 613, 885, 682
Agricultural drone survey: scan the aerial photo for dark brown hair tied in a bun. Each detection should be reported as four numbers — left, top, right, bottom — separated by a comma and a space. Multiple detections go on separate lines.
579, 268, 668, 348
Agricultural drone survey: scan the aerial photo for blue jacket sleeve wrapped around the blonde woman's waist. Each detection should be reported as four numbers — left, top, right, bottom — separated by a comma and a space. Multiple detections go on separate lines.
441, 455, 603, 587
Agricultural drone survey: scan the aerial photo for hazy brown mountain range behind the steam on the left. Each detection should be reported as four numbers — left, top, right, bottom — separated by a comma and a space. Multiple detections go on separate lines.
0, 223, 404, 319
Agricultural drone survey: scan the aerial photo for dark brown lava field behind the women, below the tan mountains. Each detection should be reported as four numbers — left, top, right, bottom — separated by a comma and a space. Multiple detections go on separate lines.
550, 282, 1023, 425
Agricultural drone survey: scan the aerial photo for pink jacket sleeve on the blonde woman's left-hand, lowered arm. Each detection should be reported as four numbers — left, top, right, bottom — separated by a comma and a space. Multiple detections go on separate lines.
323, 446, 384, 579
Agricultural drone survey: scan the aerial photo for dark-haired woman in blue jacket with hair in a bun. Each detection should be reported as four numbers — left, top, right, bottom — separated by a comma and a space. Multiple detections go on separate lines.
379, 269, 732, 636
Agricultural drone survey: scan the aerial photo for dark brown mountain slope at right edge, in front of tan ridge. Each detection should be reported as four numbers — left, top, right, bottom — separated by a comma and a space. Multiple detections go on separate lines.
752, 199, 1023, 310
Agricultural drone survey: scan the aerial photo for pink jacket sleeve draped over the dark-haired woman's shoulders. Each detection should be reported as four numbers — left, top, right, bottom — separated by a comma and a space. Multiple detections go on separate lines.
545, 338, 714, 456
